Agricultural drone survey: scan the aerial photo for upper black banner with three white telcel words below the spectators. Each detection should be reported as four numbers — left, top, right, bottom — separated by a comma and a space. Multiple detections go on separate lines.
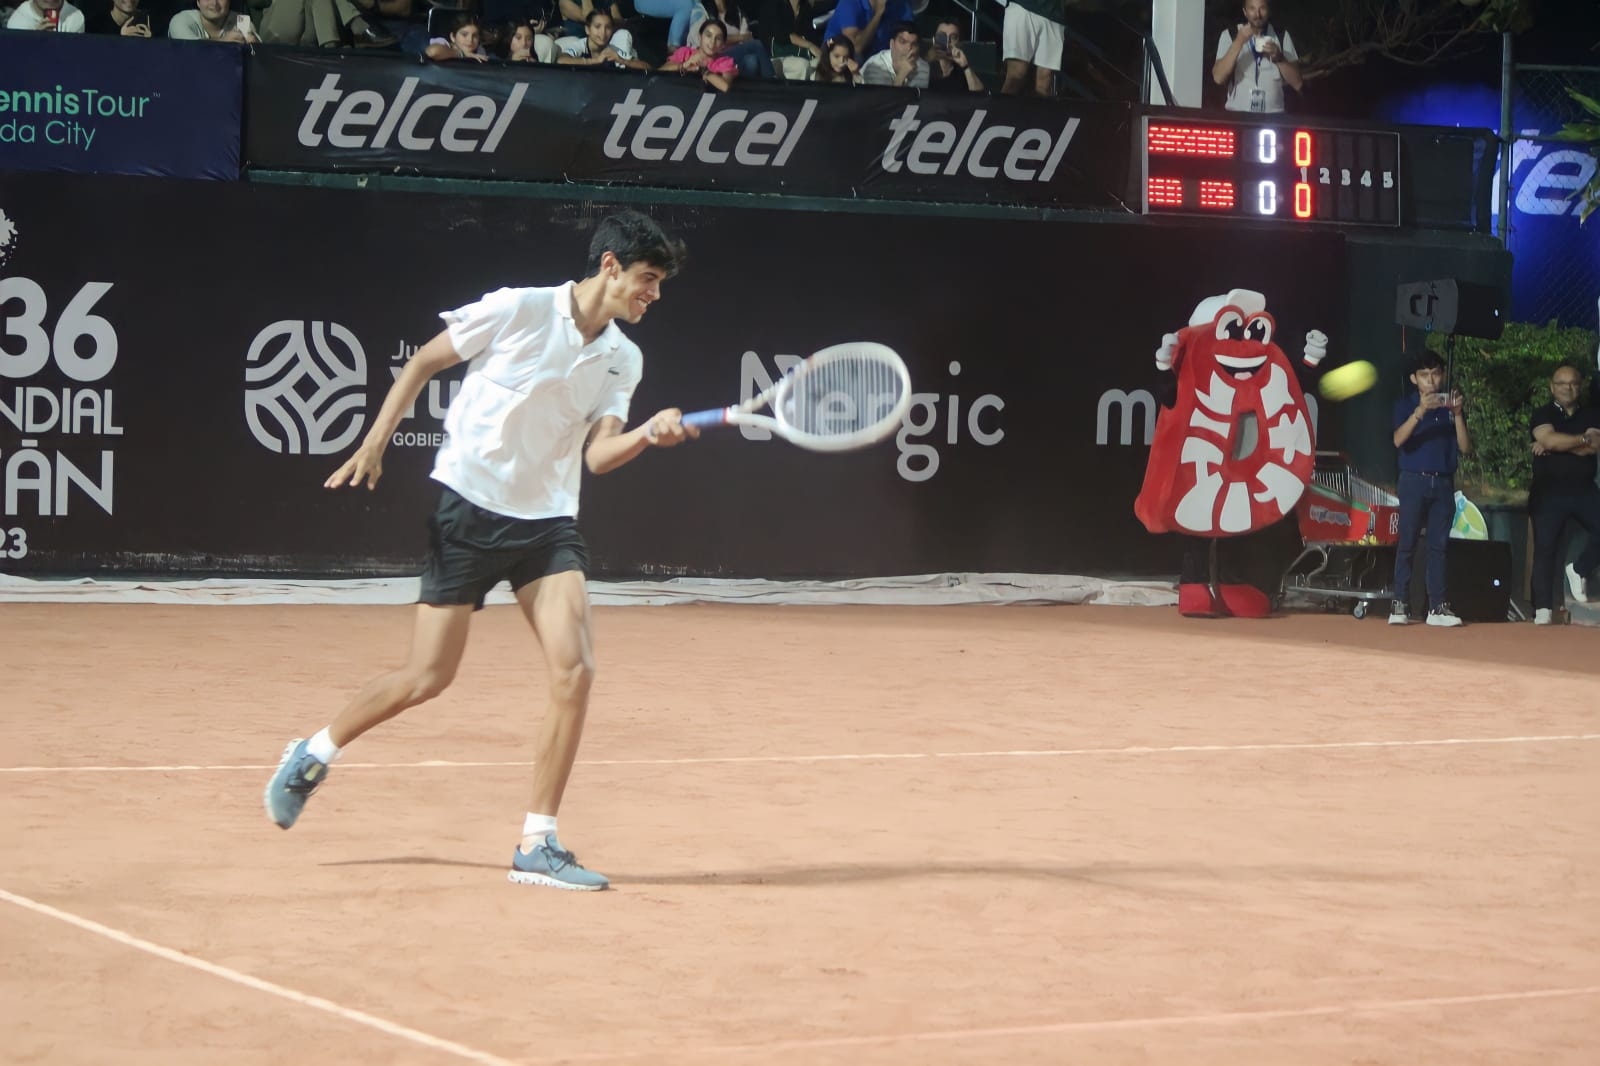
246, 50, 1131, 208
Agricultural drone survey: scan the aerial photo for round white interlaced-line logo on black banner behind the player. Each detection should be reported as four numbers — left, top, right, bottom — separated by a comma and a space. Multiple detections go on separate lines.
245, 319, 366, 455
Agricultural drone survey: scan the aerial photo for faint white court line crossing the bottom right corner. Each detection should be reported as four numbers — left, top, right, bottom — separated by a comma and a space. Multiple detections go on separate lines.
562, 984, 1600, 1063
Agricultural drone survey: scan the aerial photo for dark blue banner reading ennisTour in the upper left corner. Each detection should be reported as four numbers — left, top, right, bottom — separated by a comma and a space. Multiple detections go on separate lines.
0, 32, 245, 179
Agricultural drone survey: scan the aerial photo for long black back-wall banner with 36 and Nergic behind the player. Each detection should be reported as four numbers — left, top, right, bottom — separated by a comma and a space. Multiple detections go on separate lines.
0, 174, 1349, 578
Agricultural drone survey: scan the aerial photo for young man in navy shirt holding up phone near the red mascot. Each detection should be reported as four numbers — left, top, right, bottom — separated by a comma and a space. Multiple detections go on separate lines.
1389, 352, 1472, 626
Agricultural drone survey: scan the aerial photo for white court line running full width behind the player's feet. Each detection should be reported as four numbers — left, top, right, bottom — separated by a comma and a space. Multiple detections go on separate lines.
0, 733, 1600, 773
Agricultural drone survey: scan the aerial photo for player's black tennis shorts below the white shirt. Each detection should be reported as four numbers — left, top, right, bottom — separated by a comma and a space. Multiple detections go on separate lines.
418, 487, 589, 610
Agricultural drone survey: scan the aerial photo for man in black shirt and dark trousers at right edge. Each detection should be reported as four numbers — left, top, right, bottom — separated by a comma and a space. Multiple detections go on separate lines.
1528, 367, 1600, 626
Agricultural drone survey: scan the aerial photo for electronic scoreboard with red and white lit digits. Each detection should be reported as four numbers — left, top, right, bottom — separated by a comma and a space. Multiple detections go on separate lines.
1139, 115, 1400, 226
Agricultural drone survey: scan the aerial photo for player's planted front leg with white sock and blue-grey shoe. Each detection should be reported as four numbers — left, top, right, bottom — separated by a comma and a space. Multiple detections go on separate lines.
510, 570, 608, 890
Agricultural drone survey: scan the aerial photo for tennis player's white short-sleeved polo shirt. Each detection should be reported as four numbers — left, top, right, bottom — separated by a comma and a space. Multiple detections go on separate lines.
434, 282, 645, 519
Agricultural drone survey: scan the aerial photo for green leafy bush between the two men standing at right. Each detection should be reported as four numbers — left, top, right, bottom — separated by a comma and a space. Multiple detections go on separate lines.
1429, 322, 1597, 503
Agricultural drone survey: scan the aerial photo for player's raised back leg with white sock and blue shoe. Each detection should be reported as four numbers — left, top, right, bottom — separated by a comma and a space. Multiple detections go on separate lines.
262, 603, 472, 829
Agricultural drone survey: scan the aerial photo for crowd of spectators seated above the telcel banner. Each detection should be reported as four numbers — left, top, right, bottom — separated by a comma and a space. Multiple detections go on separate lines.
0, 0, 1066, 94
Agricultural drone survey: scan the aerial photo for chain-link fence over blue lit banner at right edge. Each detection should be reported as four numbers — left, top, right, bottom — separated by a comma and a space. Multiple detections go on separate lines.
1510, 66, 1600, 330
